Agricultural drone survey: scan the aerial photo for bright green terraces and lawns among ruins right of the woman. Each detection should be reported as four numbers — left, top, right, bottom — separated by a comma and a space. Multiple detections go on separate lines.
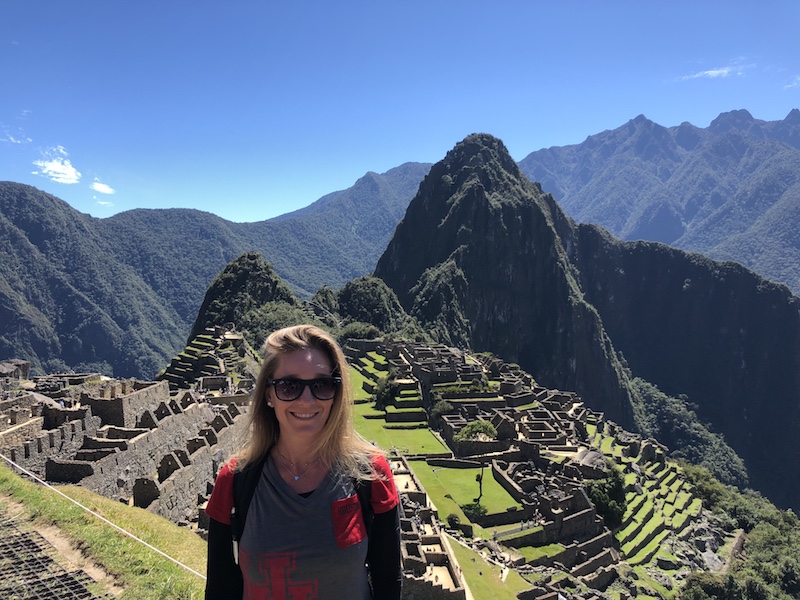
351, 342, 716, 598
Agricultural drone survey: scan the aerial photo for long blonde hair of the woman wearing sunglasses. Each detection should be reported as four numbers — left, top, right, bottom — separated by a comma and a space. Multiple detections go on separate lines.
238, 325, 383, 479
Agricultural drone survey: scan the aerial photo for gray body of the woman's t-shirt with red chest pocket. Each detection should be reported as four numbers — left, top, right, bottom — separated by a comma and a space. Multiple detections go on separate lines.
239, 457, 371, 600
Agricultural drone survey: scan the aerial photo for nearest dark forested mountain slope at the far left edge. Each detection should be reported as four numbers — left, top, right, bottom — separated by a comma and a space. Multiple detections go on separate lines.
0, 184, 182, 375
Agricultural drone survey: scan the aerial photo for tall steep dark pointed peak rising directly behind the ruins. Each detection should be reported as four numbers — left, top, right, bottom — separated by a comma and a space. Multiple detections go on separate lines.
375, 135, 633, 432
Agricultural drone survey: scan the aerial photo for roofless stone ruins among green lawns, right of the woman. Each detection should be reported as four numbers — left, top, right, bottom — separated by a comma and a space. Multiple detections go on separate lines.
345, 340, 712, 600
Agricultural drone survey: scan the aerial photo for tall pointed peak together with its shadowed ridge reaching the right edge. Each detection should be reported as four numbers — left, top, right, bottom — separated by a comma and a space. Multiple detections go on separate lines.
375, 134, 800, 507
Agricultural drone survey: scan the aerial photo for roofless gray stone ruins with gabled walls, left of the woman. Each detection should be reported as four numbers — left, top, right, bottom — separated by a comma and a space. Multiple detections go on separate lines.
0, 377, 247, 525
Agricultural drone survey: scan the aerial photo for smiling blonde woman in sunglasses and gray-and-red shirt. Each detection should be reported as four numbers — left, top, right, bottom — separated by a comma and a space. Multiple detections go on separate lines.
206, 325, 402, 600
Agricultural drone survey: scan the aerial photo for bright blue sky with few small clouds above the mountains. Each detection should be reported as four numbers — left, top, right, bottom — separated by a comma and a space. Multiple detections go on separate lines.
0, 0, 800, 221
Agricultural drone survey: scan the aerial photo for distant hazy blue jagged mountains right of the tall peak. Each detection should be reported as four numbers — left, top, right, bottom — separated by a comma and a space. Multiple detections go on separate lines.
519, 109, 800, 295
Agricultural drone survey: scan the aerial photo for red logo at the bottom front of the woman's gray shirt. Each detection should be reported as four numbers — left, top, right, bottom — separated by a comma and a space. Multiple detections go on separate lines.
241, 552, 318, 600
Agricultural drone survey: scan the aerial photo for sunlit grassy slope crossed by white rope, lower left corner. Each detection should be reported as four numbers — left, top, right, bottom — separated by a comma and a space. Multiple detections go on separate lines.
0, 465, 206, 600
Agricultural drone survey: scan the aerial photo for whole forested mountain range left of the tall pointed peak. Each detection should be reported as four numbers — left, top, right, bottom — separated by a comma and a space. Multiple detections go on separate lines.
0, 163, 429, 379
